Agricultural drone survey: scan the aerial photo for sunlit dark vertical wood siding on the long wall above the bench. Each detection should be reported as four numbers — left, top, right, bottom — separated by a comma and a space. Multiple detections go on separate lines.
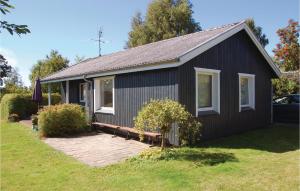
95, 68, 178, 127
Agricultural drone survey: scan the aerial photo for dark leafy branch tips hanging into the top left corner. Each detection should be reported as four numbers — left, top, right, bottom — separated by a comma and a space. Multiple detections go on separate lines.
0, 0, 30, 35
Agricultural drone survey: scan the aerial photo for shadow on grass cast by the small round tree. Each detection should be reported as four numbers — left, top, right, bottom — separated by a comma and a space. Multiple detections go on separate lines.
158, 148, 238, 166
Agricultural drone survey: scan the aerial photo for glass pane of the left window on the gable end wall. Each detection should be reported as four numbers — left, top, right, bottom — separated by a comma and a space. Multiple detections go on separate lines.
198, 74, 212, 108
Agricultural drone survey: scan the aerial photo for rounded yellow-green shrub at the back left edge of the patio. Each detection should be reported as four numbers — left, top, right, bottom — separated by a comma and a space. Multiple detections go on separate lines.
38, 104, 87, 137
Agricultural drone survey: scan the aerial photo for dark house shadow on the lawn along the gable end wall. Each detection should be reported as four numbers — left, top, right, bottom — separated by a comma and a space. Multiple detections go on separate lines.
200, 124, 299, 153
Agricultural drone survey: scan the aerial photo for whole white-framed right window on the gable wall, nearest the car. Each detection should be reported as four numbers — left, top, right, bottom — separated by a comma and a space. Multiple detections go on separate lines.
239, 73, 255, 111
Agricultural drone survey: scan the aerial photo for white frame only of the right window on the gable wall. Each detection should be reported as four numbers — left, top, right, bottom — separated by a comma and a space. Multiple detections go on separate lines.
238, 73, 255, 112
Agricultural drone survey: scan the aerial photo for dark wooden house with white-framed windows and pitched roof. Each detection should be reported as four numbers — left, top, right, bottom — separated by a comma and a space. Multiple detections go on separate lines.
42, 21, 280, 144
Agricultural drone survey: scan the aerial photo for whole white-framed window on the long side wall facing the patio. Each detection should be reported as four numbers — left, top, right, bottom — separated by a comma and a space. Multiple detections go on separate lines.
94, 77, 114, 114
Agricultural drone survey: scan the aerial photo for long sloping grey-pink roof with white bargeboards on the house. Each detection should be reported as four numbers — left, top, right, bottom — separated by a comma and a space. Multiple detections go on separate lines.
41, 21, 280, 83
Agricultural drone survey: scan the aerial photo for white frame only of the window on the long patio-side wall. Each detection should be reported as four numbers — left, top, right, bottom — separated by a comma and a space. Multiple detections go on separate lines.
94, 76, 115, 115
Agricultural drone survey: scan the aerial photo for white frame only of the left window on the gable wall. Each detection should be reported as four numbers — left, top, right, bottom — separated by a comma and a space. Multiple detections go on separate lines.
194, 67, 221, 116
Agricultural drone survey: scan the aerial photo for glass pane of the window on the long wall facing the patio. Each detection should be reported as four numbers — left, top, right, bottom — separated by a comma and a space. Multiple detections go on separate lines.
100, 79, 113, 107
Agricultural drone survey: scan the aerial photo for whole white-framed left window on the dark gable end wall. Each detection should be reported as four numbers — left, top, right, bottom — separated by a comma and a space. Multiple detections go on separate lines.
195, 68, 220, 115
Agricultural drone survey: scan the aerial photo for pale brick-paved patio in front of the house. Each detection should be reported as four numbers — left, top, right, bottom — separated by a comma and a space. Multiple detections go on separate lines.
21, 121, 149, 167
